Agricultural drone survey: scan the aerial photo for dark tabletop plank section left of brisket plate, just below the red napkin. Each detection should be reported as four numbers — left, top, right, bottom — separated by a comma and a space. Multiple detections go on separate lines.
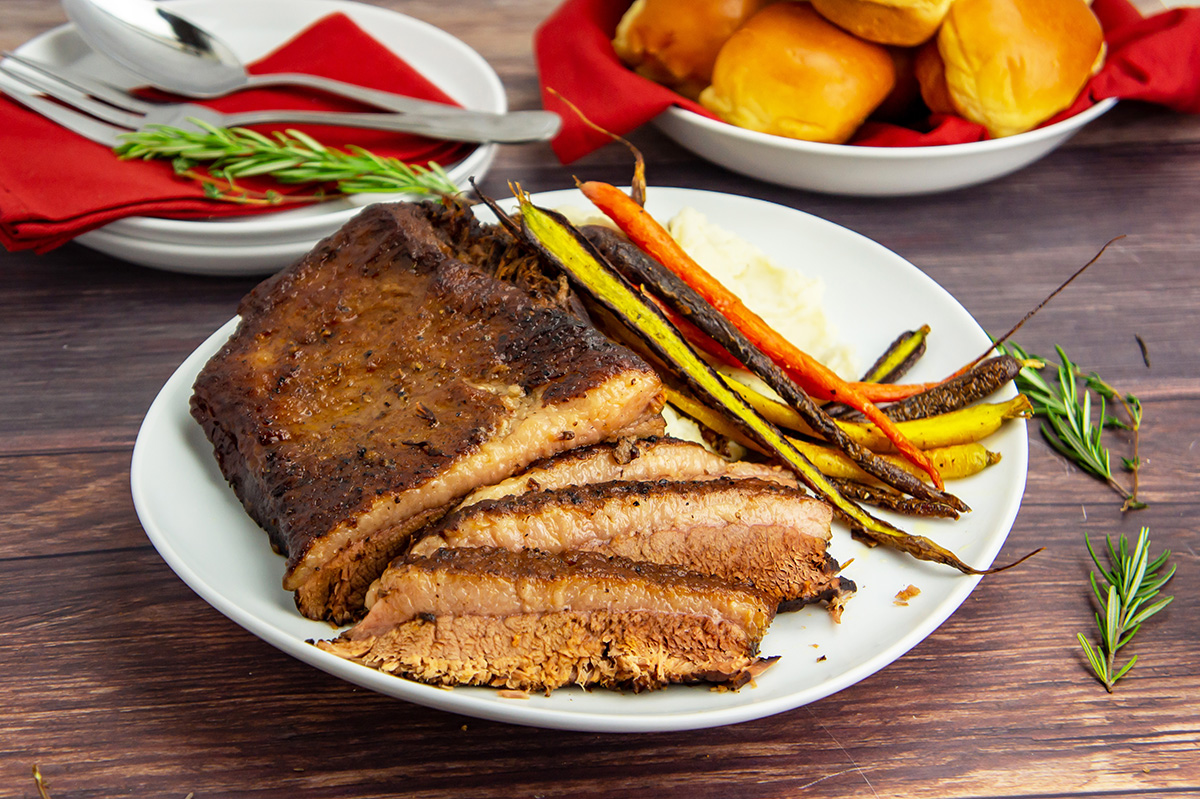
0, 245, 257, 452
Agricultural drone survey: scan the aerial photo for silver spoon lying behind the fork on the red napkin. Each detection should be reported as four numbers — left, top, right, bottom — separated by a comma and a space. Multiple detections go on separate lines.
62, 0, 562, 142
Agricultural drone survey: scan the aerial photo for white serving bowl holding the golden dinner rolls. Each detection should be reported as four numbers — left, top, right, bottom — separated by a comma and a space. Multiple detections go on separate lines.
654, 100, 1116, 197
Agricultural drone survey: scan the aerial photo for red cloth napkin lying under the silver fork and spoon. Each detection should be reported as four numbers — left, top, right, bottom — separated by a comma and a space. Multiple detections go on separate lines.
0, 13, 474, 252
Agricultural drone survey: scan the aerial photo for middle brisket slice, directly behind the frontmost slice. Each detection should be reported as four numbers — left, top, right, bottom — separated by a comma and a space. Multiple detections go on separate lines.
409, 477, 854, 613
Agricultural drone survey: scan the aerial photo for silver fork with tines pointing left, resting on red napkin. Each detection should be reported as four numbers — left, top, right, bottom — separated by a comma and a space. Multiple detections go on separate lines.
0, 53, 558, 146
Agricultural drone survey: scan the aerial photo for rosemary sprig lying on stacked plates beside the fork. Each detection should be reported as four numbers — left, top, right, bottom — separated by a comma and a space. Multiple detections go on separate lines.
115, 119, 458, 204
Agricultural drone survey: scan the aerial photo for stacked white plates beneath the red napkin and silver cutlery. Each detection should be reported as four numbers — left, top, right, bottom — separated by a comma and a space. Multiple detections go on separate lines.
17, 0, 508, 275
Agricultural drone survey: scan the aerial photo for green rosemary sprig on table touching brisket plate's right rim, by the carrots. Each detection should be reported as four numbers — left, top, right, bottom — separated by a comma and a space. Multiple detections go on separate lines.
1001, 342, 1146, 511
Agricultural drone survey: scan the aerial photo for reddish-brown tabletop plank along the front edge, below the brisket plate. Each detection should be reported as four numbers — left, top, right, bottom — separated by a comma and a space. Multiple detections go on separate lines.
0, 527, 1200, 797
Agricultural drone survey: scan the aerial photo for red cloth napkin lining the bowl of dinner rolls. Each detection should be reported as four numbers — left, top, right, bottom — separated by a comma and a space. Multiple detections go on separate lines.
534, 0, 1200, 163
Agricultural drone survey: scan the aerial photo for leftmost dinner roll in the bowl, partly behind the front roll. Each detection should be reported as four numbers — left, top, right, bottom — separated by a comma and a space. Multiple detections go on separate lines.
612, 0, 772, 100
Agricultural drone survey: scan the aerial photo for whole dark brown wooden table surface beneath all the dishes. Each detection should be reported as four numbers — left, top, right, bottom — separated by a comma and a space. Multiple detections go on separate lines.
0, 0, 1200, 799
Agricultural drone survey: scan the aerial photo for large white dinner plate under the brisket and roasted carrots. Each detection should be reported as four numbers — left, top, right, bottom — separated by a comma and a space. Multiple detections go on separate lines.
131, 188, 1027, 732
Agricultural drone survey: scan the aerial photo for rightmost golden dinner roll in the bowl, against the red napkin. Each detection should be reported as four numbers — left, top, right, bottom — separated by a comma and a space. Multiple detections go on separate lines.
917, 0, 1104, 137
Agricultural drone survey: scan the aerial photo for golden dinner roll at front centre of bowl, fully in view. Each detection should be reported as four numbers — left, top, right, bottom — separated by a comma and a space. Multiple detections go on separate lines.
700, 1, 895, 144
